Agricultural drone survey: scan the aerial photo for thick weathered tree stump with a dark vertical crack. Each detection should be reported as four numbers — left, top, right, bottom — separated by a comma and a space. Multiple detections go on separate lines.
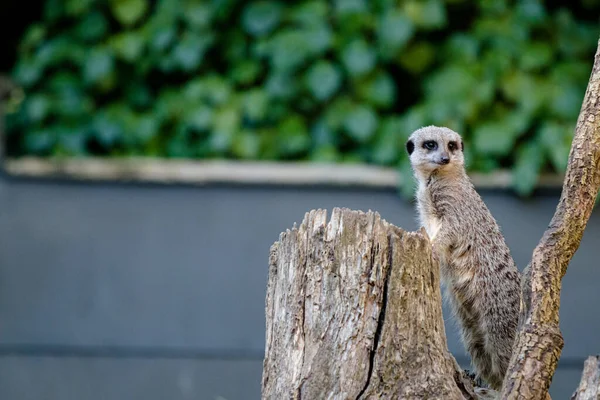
262, 209, 474, 399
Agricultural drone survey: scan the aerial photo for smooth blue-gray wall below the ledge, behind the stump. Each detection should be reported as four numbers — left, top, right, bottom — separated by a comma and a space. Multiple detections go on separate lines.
0, 177, 600, 400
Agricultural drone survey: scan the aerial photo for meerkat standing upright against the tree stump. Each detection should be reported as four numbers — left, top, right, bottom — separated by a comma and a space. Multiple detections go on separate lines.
406, 126, 520, 390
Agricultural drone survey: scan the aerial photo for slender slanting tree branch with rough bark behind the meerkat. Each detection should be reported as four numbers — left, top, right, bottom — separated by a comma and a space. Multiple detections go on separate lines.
501, 38, 600, 399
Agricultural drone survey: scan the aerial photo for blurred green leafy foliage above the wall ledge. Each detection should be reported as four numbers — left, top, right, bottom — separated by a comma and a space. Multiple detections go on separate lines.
7, 0, 600, 195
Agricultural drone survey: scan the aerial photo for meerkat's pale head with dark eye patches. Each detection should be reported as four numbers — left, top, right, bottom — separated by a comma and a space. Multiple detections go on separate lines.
406, 125, 464, 175
